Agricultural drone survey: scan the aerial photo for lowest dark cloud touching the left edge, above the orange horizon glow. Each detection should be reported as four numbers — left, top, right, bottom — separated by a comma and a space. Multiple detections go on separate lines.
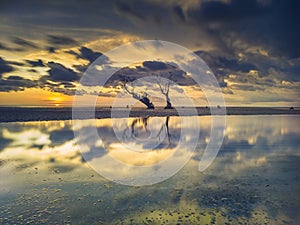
0, 76, 36, 92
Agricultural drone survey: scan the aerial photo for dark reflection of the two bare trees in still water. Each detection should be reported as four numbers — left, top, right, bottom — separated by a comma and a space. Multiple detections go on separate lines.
123, 116, 176, 149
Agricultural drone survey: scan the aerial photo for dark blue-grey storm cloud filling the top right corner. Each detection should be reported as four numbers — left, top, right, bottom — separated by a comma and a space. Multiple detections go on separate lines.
187, 0, 300, 58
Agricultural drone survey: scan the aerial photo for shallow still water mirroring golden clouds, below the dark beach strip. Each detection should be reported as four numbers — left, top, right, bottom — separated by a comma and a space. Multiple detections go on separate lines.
0, 115, 300, 224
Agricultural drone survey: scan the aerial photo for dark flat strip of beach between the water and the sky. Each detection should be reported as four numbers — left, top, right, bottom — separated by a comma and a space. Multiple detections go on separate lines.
0, 107, 300, 122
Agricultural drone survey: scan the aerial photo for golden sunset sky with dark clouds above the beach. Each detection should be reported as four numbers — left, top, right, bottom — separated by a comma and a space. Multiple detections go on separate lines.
0, 0, 300, 107
